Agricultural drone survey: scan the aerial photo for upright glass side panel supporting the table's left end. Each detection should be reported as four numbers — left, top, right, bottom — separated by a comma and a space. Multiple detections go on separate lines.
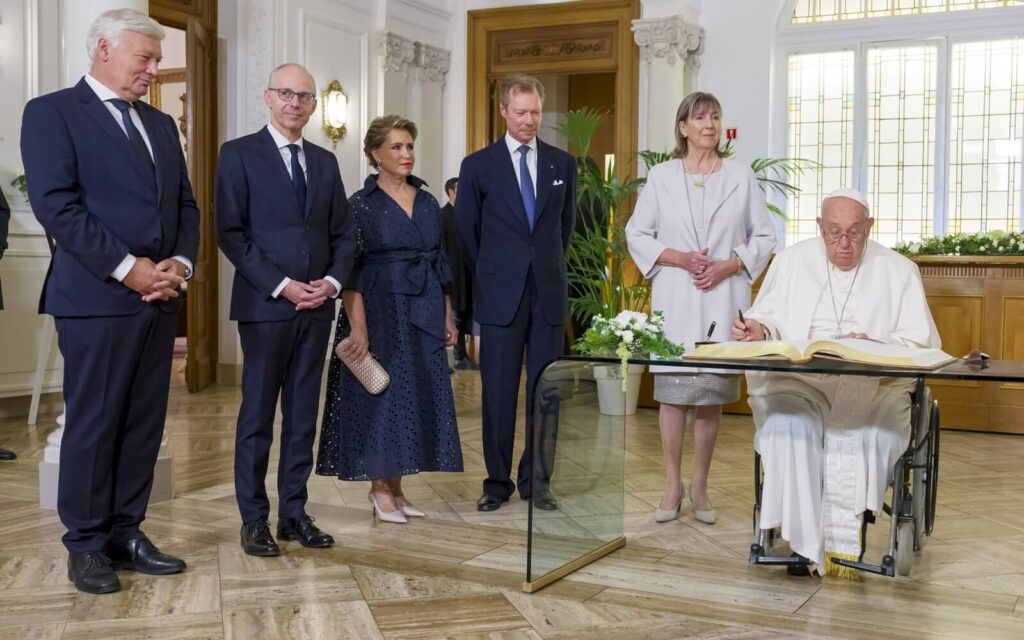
526, 360, 622, 583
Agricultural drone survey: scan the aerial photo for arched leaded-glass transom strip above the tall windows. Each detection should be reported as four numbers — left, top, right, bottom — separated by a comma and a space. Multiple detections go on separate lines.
793, 0, 1024, 25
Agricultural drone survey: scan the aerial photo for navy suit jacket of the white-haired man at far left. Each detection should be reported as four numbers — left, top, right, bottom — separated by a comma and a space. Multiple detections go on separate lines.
22, 79, 199, 317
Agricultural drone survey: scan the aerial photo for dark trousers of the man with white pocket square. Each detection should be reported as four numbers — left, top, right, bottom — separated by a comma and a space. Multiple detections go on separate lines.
480, 270, 565, 498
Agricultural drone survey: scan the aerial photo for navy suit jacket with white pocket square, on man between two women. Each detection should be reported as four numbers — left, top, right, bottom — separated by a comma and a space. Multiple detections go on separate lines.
455, 135, 577, 326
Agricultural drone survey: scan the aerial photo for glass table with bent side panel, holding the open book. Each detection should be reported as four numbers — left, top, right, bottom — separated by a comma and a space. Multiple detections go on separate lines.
522, 356, 1024, 593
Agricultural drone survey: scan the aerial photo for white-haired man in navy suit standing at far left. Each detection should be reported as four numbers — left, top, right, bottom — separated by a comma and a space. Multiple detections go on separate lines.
22, 9, 199, 593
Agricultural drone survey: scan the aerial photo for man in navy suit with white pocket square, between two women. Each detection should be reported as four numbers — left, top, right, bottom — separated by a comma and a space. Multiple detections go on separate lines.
455, 75, 577, 511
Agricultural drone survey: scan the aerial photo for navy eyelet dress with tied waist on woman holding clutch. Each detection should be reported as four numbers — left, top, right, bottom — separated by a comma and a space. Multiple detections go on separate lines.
316, 175, 462, 480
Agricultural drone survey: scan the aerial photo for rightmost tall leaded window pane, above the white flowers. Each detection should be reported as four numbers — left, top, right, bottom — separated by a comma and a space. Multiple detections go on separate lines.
948, 38, 1024, 232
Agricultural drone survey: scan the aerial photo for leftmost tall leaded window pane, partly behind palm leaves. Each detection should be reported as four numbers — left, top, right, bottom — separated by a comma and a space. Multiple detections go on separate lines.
786, 51, 853, 244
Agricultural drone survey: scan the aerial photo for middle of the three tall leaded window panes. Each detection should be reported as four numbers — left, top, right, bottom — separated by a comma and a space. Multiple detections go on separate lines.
867, 46, 936, 247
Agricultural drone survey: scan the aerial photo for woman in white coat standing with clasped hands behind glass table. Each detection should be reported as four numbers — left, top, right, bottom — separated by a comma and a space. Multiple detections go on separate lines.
626, 91, 775, 524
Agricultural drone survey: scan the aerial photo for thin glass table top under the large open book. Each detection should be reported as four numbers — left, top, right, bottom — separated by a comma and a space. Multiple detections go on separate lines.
555, 355, 1024, 382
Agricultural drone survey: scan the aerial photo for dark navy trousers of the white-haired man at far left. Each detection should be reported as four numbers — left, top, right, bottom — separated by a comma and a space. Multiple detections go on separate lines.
55, 305, 176, 553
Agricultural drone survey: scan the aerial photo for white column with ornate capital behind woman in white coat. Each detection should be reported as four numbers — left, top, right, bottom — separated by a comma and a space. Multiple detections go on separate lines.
633, 15, 703, 168
